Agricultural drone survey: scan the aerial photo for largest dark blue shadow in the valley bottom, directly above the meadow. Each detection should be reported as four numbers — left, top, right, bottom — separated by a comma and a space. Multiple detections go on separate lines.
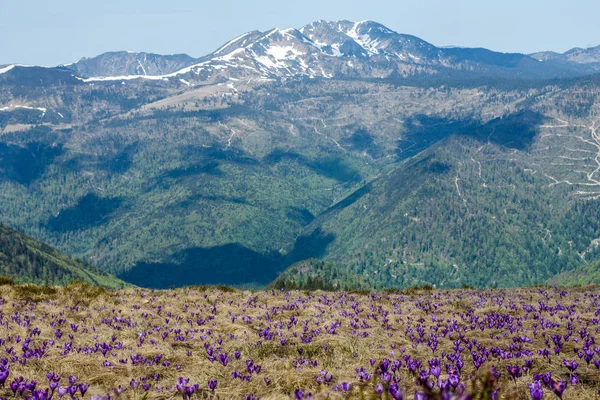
119, 243, 282, 289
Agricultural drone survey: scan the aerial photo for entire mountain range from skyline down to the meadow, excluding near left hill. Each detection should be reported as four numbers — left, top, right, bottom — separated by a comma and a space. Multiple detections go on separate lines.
0, 21, 600, 288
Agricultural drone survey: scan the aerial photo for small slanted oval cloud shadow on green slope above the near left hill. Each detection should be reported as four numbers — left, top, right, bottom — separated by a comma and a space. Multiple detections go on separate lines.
46, 193, 123, 233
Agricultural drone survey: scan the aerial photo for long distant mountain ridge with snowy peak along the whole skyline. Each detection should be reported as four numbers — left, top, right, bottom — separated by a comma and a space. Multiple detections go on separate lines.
0, 20, 600, 83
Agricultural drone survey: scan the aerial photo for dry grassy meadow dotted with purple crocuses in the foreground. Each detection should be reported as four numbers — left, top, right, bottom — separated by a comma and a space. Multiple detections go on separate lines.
0, 283, 600, 399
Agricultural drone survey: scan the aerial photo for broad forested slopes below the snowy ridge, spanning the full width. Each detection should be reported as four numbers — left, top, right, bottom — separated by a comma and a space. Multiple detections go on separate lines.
0, 71, 600, 288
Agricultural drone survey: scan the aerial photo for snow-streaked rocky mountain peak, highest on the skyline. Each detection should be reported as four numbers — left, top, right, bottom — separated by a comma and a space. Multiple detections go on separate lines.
70, 20, 450, 83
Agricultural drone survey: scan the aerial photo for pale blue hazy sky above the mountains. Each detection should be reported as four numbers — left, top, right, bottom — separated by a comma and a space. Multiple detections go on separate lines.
0, 0, 600, 65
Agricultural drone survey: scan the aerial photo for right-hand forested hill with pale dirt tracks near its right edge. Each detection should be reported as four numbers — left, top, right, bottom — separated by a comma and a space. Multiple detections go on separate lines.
279, 98, 600, 288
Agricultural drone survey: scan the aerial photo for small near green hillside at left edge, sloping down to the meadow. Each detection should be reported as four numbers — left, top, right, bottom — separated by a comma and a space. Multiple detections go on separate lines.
0, 224, 126, 289
